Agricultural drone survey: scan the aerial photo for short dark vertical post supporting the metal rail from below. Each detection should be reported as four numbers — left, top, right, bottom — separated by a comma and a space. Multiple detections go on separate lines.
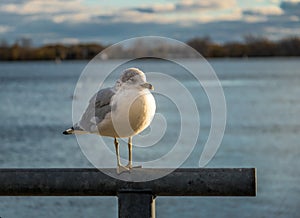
118, 190, 155, 218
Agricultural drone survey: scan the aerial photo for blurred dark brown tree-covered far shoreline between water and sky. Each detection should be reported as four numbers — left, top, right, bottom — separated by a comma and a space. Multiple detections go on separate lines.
0, 36, 300, 60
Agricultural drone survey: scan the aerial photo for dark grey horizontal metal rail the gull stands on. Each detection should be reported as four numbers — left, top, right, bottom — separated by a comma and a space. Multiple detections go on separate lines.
0, 168, 256, 196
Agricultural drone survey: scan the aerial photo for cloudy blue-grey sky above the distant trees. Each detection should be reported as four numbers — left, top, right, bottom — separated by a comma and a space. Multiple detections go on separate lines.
0, 0, 300, 45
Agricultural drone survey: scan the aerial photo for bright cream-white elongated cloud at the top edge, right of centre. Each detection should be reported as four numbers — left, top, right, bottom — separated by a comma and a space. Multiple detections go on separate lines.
102, 0, 241, 25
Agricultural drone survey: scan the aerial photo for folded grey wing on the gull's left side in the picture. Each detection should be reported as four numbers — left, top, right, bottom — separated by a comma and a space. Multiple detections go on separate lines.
79, 88, 115, 132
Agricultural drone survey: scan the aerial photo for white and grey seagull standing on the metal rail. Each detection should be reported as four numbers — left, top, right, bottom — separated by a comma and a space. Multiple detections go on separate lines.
63, 68, 156, 174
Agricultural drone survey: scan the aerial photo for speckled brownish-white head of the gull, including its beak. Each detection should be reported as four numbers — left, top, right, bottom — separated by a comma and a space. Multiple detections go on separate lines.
115, 68, 153, 90
